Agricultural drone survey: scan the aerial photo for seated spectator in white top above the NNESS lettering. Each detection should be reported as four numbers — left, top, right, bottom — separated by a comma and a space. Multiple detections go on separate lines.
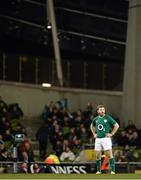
60, 147, 75, 161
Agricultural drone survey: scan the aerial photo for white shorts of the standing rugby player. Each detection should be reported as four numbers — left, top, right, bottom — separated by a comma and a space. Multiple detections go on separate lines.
95, 137, 112, 151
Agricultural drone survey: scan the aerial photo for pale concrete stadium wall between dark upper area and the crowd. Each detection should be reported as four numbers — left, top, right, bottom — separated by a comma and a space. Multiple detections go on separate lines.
0, 81, 122, 118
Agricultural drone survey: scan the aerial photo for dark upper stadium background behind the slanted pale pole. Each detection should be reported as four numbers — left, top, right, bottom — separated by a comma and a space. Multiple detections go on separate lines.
0, 0, 129, 91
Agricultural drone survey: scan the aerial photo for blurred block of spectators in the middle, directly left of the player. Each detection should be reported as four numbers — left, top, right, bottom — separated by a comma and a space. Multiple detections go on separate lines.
36, 102, 93, 161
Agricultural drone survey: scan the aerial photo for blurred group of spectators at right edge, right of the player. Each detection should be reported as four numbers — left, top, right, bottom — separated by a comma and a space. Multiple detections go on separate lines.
115, 120, 141, 162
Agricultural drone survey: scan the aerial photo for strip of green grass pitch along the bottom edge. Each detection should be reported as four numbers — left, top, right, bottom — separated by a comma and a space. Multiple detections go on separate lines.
0, 174, 141, 180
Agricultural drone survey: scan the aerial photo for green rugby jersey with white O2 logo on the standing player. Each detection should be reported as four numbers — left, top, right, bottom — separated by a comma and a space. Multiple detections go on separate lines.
92, 114, 116, 138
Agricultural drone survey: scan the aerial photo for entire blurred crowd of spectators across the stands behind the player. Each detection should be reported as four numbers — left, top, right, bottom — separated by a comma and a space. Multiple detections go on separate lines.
0, 97, 141, 174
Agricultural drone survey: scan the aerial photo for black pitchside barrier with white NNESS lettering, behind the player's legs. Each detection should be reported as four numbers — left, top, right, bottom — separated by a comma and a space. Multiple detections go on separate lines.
0, 162, 141, 174
